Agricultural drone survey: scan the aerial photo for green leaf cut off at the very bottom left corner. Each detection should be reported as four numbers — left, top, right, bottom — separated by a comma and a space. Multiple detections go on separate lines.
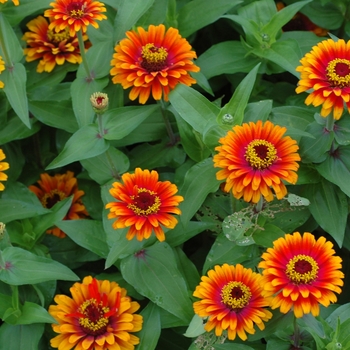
0, 323, 44, 350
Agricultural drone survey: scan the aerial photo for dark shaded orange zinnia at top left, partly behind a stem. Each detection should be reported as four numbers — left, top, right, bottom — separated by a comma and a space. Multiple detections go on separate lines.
22, 16, 90, 73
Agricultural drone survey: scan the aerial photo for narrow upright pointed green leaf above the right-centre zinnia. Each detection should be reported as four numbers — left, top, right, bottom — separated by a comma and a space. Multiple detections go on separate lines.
216, 64, 260, 129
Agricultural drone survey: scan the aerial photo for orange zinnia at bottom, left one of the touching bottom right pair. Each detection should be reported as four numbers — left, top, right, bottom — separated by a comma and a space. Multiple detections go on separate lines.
193, 264, 272, 340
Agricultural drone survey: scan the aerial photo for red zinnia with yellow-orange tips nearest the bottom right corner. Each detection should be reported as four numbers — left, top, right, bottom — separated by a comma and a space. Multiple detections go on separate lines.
258, 232, 344, 317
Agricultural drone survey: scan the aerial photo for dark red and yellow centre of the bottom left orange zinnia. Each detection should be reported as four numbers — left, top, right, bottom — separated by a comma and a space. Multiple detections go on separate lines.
78, 299, 109, 336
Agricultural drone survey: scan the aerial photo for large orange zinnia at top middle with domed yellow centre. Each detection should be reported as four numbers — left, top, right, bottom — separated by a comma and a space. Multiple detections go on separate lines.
110, 24, 199, 104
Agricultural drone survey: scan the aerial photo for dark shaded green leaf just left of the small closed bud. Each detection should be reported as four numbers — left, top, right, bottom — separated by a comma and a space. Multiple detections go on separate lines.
29, 101, 78, 133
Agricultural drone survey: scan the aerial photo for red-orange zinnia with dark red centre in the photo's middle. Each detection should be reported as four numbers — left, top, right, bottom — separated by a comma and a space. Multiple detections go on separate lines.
106, 168, 183, 241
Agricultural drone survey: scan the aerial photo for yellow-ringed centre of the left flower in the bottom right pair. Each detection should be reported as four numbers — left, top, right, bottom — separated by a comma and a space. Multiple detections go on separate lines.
221, 281, 252, 312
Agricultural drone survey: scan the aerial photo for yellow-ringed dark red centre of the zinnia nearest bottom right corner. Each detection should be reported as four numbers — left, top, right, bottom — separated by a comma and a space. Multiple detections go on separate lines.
286, 254, 318, 284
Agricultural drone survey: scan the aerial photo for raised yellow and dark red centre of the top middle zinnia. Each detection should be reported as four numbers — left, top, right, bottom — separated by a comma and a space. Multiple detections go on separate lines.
141, 43, 168, 72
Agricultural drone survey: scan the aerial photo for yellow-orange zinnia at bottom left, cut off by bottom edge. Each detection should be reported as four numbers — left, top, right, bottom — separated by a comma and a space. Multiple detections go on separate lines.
49, 276, 143, 350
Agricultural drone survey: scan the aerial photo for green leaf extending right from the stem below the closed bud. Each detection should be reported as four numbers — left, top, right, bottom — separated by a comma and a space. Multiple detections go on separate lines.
102, 105, 160, 140
